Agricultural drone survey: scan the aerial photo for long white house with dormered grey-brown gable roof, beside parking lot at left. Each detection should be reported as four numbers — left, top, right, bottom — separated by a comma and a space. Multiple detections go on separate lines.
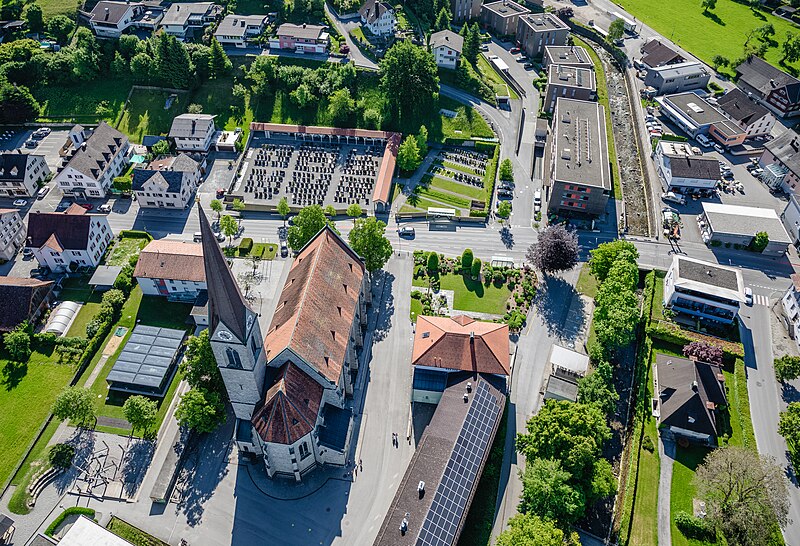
55, 121, 130, 197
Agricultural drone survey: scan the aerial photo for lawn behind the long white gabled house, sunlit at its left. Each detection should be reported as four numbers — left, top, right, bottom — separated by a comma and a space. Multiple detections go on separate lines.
117, 89, 189, 143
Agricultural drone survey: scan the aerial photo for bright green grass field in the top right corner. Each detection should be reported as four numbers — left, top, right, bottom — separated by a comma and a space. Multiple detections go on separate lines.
616, 0, 800, 77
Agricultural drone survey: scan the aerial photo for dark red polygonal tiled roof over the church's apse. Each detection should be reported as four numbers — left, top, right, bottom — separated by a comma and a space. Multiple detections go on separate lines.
251, 362, 323, 445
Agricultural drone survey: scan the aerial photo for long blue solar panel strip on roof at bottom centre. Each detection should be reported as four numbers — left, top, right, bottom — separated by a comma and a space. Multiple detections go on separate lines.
417, 382, 500, 546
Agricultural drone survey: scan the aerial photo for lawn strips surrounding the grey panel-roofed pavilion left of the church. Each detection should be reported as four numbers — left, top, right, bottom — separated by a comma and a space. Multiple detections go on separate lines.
91, 286, 192, 434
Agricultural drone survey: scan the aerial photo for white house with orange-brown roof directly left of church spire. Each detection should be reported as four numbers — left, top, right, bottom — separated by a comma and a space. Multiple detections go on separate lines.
133, 239, 206, 301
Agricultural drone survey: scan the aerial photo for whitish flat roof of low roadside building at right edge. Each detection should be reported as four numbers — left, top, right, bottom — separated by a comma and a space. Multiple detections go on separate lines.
703, 203, 792, 244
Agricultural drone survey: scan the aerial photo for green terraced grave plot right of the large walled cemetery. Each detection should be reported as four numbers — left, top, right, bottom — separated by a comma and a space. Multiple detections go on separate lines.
403, 148, 489, 216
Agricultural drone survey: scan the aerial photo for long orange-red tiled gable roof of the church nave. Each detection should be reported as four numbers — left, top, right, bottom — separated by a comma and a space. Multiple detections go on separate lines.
264, 227, 364, 383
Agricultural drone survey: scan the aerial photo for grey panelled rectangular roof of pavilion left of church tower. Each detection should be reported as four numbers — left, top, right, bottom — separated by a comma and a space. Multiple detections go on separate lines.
107, 324, 186, 390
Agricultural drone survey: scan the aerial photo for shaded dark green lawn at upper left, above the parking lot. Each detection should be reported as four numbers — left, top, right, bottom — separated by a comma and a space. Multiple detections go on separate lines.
33, 77, 131, 124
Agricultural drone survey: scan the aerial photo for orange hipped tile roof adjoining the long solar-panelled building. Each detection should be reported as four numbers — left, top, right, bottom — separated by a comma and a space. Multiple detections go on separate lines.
411, 315, 511, 375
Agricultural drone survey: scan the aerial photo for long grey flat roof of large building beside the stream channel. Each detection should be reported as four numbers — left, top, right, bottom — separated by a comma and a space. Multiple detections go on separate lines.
551, 97, 611, 190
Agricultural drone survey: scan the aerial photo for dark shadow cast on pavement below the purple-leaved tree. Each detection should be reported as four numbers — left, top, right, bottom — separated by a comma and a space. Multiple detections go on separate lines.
533, 276, 586, 341
